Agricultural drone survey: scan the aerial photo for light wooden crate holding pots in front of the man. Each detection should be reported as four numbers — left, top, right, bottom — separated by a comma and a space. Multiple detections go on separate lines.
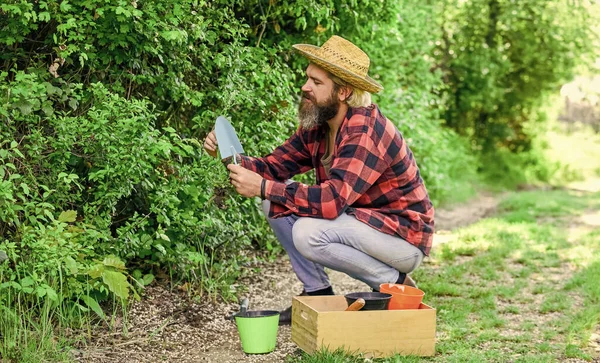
292, 296, 435, 358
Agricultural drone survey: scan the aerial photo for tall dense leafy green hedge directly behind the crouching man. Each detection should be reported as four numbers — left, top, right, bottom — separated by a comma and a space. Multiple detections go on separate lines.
0, 1, 475, 302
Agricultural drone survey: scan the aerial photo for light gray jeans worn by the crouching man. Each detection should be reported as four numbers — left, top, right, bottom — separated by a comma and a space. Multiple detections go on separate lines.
262, 200, 424, 292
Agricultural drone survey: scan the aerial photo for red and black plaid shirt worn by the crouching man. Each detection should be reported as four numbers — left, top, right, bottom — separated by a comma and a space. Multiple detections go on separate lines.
242, 105, 434, 255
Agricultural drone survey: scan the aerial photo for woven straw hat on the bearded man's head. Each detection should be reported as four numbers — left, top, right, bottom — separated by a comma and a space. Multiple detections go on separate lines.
293, 35, 383, 93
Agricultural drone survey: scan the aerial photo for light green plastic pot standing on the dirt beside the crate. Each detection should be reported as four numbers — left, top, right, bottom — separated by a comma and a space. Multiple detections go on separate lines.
235, 310, 279, 354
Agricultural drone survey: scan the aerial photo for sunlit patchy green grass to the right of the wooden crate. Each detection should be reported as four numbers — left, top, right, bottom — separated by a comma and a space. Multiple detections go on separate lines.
288, 190, 600, 362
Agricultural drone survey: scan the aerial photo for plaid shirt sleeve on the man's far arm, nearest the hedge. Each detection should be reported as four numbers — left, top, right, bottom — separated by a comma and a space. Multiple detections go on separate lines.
241, 127, 313, 181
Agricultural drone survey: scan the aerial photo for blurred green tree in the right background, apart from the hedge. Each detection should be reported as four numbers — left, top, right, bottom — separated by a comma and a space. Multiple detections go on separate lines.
434, 0, 600, 185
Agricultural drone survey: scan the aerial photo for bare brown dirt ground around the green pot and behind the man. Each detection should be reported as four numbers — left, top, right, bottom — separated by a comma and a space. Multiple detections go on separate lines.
72, 189, 600, 363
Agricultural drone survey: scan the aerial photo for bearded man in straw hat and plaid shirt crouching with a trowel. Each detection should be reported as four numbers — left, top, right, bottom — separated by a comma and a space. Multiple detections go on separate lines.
204, 36, 434, 324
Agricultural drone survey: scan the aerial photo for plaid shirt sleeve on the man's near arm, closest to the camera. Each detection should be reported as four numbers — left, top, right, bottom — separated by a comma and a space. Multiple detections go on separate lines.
265, 128, 388, 219
